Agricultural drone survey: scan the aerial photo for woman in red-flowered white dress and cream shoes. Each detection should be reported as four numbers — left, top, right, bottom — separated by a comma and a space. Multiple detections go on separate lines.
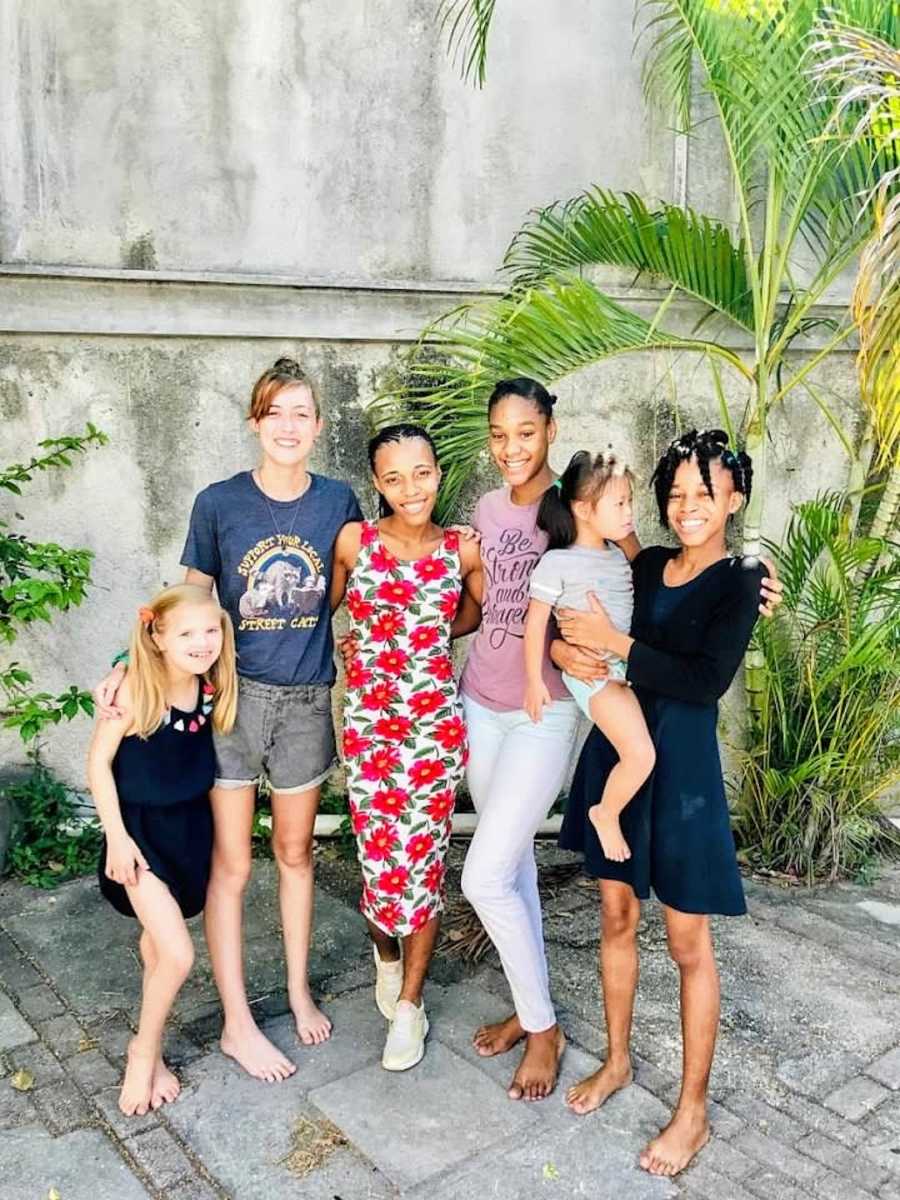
331, 425, 481, 1070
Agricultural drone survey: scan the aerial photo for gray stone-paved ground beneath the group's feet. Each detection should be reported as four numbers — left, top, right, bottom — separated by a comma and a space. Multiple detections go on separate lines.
0, 850, 900, 1200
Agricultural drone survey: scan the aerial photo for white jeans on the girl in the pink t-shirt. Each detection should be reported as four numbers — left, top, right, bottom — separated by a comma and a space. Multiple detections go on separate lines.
462, 696, 578, 1033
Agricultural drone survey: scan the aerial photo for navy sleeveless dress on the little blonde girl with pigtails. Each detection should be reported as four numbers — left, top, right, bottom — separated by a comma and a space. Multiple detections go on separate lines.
98, 680, 216, 917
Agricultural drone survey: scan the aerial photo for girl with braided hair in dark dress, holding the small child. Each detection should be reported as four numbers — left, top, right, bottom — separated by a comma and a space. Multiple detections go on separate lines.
559, 430, 766, 1176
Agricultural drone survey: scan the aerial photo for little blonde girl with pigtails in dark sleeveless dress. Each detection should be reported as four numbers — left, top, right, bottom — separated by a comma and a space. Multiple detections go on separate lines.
88, 584, 236, 1116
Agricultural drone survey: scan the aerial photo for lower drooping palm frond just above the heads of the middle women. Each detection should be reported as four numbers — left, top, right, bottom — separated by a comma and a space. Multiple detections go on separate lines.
373, 276, 749, 518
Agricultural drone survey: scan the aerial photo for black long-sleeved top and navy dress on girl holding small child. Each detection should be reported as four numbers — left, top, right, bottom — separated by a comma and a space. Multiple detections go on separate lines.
559, 546, 764, 916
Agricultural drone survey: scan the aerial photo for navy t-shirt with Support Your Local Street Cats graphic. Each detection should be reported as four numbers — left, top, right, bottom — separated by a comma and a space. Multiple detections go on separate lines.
181, 470, 362, 686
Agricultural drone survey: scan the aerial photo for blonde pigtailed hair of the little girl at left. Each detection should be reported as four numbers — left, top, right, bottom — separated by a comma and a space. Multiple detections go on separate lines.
128, 583, 238, 738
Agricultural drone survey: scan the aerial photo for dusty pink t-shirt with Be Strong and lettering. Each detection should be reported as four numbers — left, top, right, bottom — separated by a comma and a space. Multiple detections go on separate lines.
461, 487, 569, 712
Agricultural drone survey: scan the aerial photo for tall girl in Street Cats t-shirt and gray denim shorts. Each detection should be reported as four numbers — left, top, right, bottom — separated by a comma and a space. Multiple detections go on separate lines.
96, 359, 362, 1081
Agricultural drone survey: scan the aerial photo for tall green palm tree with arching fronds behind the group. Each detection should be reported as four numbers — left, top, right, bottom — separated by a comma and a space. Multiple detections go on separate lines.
382, 0, 900, 554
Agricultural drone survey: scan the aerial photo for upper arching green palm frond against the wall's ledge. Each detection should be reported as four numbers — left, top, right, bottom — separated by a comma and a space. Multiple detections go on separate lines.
503, 187, 754, 330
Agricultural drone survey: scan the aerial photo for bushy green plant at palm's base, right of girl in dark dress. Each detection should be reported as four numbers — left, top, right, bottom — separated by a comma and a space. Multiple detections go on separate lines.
736, 494, 900, 882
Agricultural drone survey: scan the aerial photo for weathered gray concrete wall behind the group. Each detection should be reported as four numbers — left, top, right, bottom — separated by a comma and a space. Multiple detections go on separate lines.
0, 0, 856, 782
